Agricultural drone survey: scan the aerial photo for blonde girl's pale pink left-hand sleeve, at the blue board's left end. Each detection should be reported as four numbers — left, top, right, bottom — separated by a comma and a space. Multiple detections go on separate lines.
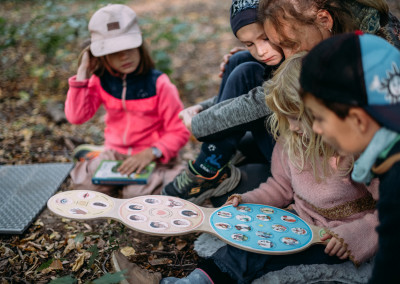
242, 141, 293, 208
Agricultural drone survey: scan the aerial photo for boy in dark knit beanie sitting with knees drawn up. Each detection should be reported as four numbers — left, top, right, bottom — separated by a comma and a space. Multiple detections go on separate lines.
162, 0, 283, 204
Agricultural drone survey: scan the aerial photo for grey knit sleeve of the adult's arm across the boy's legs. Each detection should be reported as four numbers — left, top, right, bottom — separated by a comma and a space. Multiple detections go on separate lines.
192, 86, 271, 141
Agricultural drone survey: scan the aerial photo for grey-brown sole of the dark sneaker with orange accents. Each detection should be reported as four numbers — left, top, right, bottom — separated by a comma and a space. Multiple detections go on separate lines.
187, 167, 241, 205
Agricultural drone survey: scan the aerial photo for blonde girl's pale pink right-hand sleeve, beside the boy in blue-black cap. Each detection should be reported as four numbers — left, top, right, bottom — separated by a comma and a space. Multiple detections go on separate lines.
327, 179, 379, 265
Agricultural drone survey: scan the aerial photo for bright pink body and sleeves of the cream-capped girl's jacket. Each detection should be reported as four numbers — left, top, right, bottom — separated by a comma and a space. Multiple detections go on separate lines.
65, 74, 190, 163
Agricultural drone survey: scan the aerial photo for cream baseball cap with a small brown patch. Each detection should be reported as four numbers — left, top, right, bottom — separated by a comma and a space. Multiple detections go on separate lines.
89, 4, 143, 56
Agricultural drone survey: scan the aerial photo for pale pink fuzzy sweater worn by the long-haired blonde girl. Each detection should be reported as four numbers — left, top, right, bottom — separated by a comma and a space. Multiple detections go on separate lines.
242, 141, 378, 265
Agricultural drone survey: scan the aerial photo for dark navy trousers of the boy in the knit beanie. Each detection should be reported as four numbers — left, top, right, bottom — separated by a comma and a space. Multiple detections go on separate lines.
202, 51, 275, 207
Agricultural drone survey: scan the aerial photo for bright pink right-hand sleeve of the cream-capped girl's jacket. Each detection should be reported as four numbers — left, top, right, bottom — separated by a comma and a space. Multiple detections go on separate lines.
152, 74, 190, 163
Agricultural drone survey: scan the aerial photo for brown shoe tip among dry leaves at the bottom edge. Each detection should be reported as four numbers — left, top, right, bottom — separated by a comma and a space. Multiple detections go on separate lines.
111, 251, 162, 284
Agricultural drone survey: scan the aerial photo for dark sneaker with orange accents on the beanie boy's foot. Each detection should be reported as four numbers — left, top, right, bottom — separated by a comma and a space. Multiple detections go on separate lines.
162, 161, 240, 205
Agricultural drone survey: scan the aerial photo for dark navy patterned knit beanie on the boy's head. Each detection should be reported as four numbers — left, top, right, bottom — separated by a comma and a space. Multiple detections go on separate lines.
231, 0, 259, 36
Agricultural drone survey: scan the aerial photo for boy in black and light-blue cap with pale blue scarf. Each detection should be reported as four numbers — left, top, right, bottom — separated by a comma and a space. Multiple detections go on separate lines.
300, 32, 400, 283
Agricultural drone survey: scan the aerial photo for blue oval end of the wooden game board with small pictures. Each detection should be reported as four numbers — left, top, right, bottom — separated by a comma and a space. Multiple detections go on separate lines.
210, 204, 313, 253
